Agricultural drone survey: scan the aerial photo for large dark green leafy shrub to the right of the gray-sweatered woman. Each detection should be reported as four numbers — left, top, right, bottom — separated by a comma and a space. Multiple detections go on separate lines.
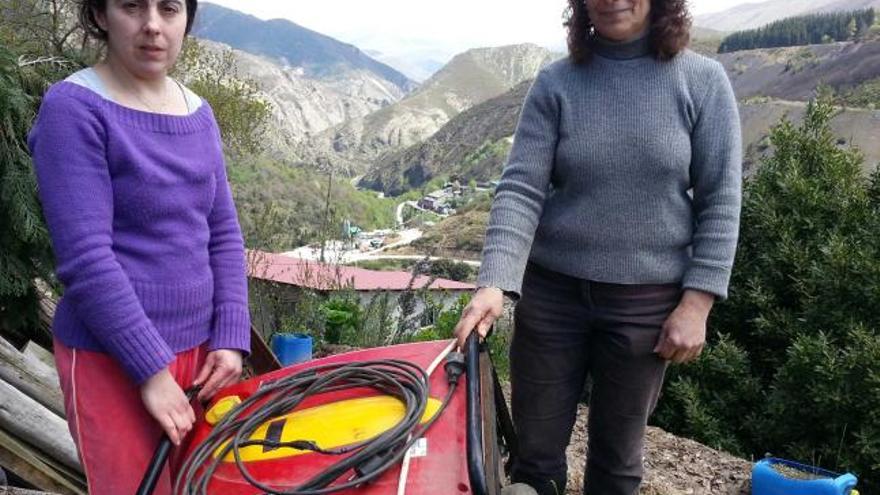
656, 95, 880, 493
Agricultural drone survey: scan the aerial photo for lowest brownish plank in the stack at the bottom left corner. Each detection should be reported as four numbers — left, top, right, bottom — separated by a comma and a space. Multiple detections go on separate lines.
0, 429, 88, 495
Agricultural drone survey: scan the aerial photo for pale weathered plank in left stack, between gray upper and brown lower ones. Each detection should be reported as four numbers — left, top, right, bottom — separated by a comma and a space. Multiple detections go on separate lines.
0, 380, 82, 472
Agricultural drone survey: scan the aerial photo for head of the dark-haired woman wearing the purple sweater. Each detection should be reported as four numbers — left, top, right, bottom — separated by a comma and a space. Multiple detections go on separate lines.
95, 0, 187, 79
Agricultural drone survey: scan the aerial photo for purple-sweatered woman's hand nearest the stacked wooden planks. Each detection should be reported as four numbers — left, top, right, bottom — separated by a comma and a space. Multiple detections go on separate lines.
141, 368, 196, 446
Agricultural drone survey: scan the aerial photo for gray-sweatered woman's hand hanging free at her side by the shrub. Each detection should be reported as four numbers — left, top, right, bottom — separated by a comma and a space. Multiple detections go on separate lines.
654, 290, 715, 363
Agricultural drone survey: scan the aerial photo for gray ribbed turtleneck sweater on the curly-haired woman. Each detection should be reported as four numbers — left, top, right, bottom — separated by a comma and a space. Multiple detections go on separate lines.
478, 38, 742, 298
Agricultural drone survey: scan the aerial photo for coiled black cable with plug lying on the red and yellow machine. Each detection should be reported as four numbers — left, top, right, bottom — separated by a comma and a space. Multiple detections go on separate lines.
174, 359, 457, 495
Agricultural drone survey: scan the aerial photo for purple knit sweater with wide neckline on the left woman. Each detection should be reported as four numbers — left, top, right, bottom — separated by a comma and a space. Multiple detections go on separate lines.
29, 82, 250, 383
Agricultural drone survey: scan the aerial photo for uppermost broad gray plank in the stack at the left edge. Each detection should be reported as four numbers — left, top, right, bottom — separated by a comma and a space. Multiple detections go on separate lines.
0, 337, 65, 418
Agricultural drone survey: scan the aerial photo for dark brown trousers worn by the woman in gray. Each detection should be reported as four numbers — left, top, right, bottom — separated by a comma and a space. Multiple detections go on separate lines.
510, 263, 681, 495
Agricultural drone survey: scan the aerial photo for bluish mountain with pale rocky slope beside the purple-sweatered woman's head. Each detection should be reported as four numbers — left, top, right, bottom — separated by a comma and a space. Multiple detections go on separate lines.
193, 3, 416, 143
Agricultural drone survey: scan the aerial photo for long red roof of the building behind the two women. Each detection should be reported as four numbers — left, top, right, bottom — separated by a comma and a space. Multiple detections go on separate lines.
247, 250, 475, 291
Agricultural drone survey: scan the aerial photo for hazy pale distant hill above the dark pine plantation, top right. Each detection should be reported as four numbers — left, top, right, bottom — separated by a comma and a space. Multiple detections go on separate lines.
694, 0, 880, 31
